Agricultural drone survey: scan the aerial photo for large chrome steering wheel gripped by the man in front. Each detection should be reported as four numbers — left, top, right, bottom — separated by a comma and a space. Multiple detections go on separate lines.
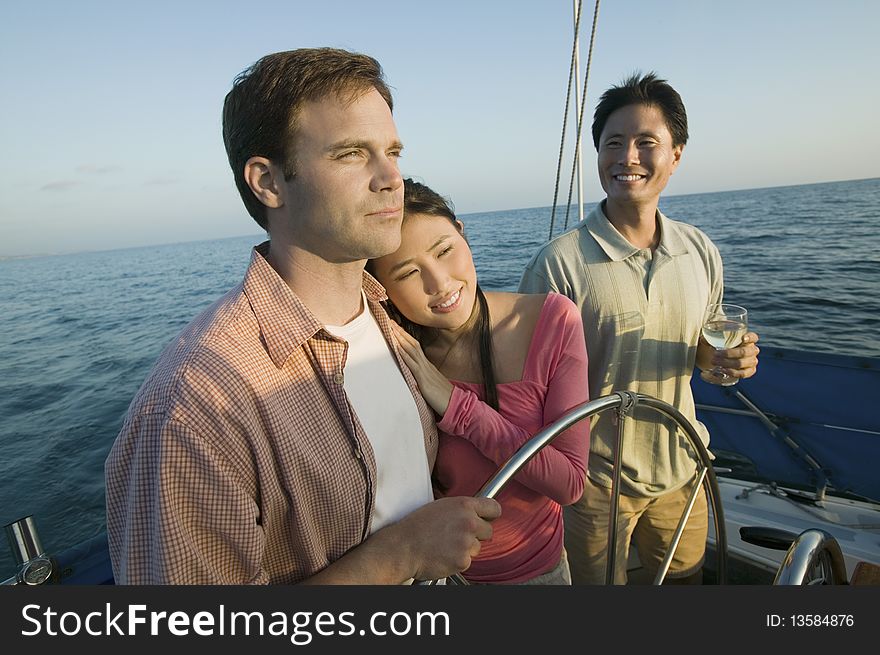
430, 391, 727, 585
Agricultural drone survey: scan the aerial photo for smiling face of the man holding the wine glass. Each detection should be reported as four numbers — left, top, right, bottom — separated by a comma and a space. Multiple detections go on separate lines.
598, 104, 684, 204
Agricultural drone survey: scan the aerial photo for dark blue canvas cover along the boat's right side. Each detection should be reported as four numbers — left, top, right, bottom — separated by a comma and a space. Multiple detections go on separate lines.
693, 348, 880, 502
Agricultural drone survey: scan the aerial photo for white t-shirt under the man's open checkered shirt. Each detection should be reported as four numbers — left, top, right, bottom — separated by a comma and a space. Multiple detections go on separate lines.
325, 299, 434, 532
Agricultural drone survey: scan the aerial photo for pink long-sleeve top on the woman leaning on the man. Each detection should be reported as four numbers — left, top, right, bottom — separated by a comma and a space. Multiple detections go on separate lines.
434, 293, 590, 583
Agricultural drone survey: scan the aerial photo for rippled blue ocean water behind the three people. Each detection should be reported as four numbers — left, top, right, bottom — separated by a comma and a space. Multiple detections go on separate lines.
0, 179, 880, 579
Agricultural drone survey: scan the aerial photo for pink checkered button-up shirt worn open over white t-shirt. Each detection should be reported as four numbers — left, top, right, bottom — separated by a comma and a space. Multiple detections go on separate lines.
105, 242, 437, 584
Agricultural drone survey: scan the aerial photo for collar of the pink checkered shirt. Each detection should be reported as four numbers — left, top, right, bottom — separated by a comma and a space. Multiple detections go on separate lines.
243, 241, 388, 368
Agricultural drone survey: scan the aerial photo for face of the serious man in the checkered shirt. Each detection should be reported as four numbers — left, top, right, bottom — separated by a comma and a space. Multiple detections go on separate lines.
284, 89, 403, 263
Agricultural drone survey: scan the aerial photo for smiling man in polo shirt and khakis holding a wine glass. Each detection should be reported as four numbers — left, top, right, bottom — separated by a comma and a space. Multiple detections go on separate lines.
519, 73, 759, 584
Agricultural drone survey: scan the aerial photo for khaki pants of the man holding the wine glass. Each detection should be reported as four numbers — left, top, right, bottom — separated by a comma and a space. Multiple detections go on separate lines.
563, 478, 709, 585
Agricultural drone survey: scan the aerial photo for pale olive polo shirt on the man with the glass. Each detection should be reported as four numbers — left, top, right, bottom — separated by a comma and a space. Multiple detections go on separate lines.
519, 206, 724, 497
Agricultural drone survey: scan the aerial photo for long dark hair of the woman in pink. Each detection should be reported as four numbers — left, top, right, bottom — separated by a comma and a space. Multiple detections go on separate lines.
367, 178, 498, 411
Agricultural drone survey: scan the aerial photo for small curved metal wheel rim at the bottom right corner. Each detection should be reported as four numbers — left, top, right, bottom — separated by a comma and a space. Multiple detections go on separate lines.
773, 528, 848, 585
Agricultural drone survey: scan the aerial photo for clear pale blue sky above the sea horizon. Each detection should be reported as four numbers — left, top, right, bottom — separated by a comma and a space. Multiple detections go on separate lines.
0, 0, 880, 257
